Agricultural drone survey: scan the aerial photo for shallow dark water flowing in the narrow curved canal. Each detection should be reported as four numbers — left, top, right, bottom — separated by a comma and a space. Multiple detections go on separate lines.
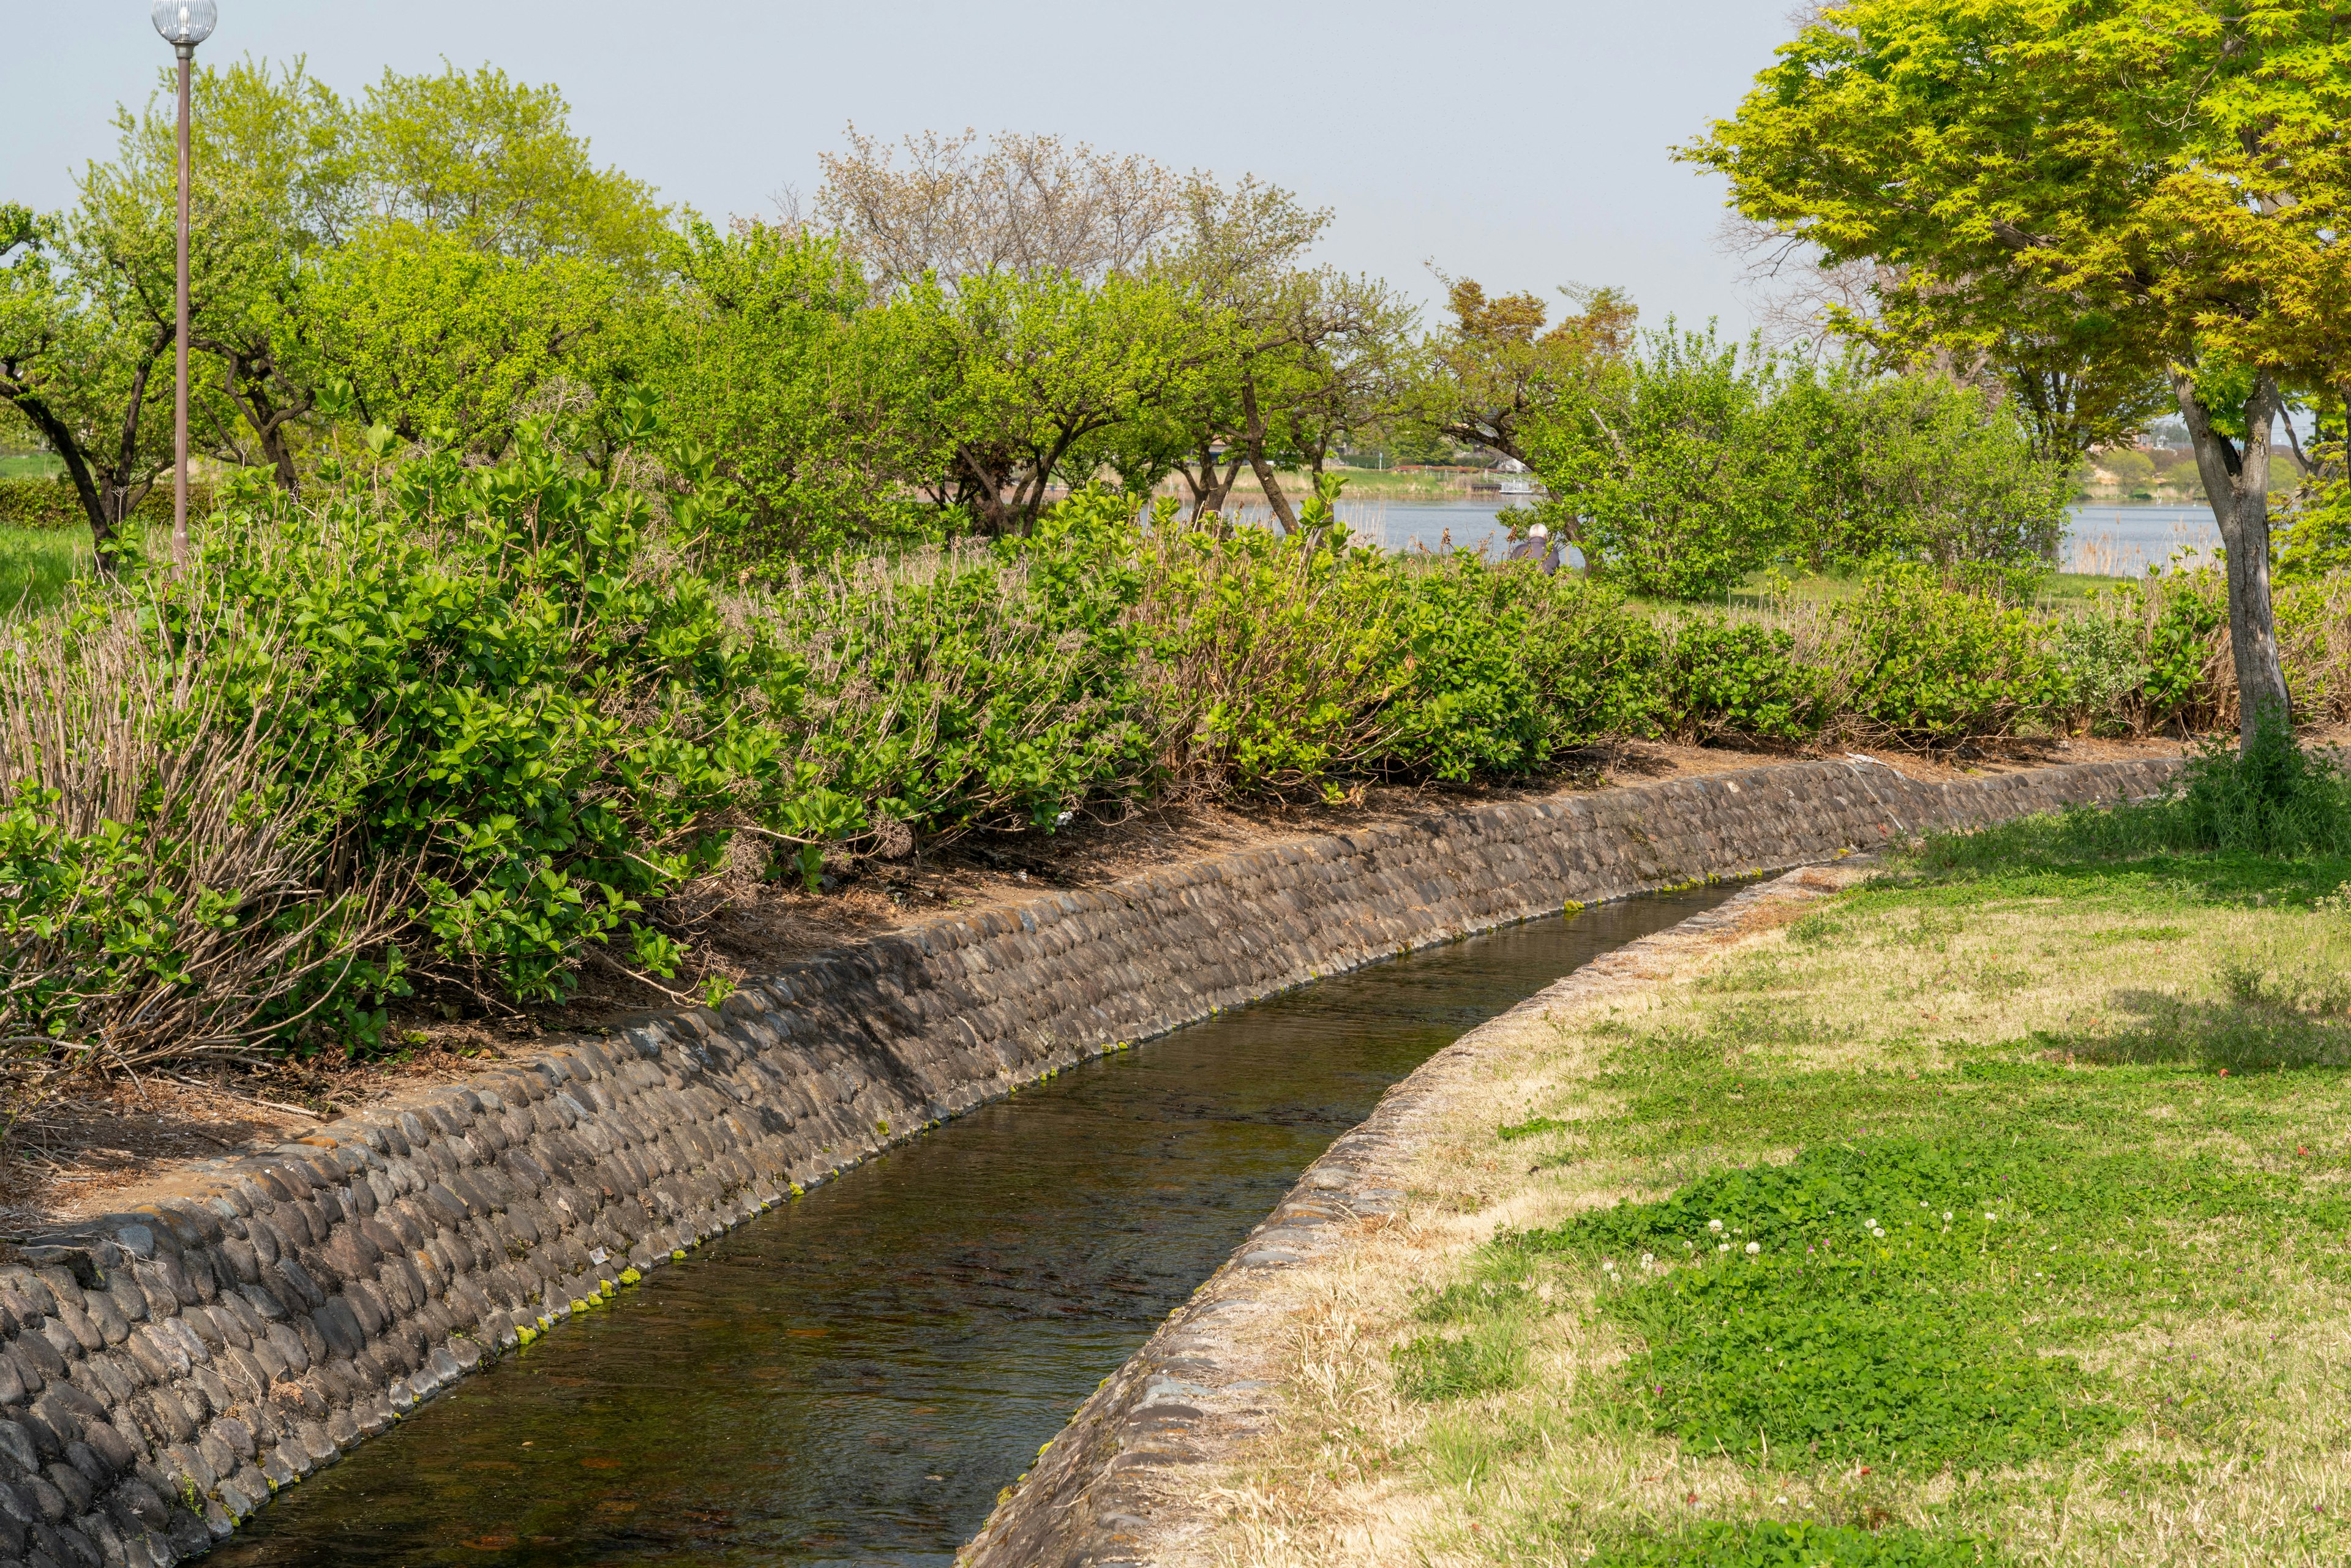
207, 888, 1728, 1568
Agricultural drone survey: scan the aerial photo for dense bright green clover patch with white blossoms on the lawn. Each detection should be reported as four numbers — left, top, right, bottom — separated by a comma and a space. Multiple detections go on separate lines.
1521, 1142, 2177, 1472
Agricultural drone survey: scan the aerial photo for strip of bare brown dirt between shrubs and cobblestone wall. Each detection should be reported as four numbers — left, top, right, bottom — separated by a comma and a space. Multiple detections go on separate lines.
0, 738, 2180, 1234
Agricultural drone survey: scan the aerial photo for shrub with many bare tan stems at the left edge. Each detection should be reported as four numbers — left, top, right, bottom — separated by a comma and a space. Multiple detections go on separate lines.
0, 593, 402, 1119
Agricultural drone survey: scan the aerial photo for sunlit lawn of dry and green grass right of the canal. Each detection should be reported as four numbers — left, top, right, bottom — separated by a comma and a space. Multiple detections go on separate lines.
1229, 835, 2351, 1568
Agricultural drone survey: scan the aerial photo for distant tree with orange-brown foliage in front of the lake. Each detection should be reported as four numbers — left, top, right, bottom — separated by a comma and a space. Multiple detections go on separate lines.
1413, 272, 1641, 465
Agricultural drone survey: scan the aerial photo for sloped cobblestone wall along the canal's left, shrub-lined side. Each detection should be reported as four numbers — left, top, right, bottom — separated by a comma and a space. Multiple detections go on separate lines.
0, 762, 2177, 1568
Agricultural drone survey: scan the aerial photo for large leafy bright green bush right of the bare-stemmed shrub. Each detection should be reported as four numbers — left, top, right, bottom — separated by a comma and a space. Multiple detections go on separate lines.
165, 425, 800, 999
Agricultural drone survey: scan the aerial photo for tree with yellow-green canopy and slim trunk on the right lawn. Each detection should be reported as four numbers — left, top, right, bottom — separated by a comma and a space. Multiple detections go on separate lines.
1683, 0, 2351, 740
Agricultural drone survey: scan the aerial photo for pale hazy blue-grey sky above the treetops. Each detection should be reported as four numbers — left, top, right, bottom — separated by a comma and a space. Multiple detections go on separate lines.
0, 0, 1789, 334
